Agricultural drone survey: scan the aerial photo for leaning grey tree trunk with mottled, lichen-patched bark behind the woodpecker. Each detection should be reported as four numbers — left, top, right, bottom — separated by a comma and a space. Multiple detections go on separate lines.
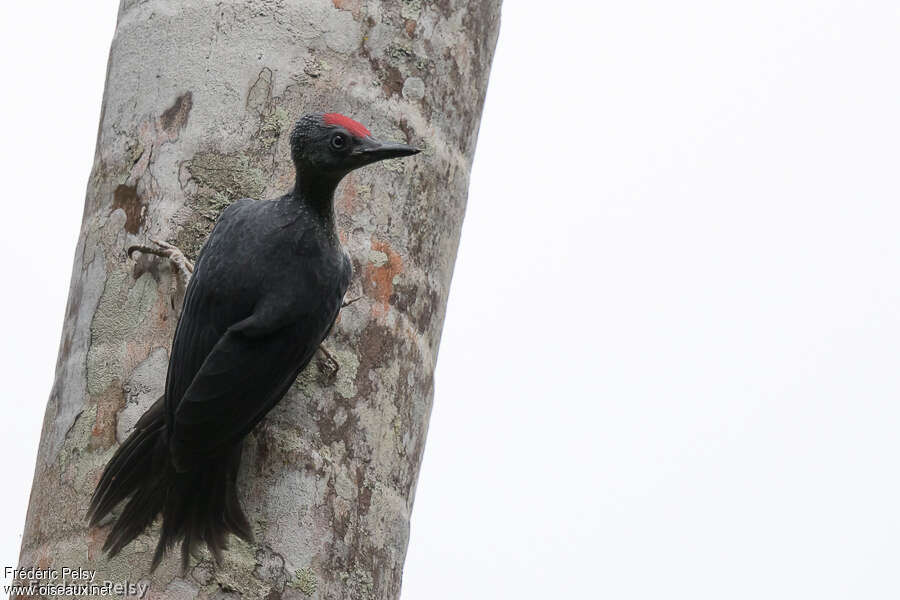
20, 0, 500, 599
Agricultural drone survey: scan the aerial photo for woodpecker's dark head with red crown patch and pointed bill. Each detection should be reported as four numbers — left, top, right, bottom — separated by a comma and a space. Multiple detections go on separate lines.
291, 113, 419, 179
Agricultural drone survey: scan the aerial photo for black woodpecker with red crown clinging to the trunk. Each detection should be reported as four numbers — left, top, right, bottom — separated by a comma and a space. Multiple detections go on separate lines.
88, 113, 418, 570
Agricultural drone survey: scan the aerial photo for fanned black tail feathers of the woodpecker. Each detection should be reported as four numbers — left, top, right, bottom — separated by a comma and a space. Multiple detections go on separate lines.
87, 398, 253, 572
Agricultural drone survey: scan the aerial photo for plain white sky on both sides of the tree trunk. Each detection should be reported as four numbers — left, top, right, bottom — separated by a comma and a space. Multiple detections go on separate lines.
0, 0, 900, 600
